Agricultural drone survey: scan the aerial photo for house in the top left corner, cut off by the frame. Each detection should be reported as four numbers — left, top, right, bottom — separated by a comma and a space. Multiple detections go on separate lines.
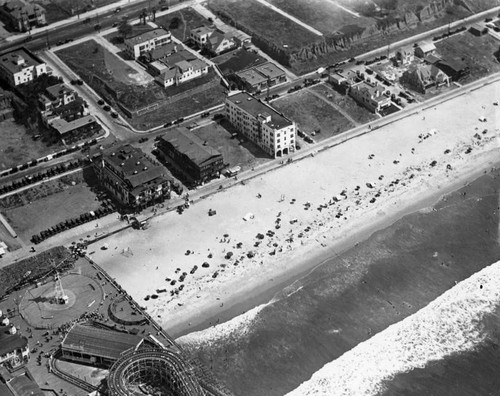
0, 0, 47, 32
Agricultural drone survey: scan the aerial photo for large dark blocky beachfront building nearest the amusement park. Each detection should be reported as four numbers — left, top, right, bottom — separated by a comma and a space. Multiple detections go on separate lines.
92, 144, 172, 210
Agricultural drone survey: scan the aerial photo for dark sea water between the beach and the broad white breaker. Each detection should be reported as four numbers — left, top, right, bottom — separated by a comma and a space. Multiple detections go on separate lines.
179, 171, 500, 396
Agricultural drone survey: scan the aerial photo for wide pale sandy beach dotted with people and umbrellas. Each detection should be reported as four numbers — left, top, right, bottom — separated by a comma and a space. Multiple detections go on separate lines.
92, 79, 500, 336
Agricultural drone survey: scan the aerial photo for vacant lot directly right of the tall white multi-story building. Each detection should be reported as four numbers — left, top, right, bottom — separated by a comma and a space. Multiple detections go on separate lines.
272, 90, 353, 141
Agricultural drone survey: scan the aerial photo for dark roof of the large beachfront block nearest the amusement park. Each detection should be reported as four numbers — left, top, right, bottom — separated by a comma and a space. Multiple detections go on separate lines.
103, 144, 172, 188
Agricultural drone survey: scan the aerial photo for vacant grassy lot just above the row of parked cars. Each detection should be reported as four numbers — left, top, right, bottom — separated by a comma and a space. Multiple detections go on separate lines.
2, 183, 100, 241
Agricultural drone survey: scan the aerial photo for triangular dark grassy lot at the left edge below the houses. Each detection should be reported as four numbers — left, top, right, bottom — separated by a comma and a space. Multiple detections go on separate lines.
0, 120, 63, 170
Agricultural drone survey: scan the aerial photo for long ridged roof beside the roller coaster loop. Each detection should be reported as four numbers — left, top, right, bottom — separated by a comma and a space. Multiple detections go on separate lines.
61, 324, 142, 359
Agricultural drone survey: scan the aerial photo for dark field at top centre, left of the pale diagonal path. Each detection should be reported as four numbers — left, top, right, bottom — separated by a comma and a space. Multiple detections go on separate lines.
208, 0, 322, 51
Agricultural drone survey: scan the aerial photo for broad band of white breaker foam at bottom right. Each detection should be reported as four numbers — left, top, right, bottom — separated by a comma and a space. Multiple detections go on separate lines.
288, 262, 500, 396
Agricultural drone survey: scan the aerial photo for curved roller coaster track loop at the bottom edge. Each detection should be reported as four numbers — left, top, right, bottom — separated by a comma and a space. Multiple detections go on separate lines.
108, 349, 205, 396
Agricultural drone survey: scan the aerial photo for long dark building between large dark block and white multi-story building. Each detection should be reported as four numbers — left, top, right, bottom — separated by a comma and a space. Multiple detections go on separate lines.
156, 127, 224, 184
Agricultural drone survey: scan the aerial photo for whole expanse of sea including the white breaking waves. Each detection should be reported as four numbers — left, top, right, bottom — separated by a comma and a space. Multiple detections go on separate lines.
179, 171, 500, 396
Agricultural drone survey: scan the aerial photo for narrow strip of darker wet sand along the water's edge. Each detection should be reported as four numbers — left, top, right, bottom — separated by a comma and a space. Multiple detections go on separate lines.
171, 151, 500, 339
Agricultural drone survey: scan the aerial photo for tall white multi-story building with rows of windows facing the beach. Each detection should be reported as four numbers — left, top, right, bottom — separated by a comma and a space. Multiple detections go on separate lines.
226, 92, 297, 158
